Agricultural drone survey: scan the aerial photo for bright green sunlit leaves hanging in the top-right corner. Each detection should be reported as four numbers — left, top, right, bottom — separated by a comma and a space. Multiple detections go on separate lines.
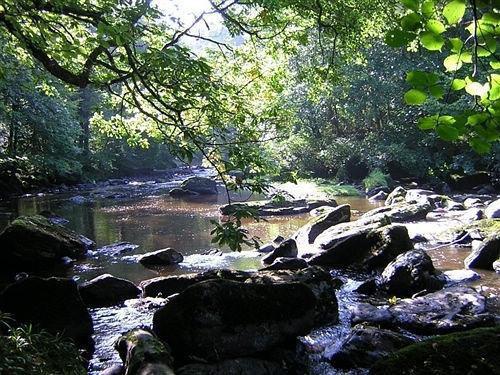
386, 0, 500, 154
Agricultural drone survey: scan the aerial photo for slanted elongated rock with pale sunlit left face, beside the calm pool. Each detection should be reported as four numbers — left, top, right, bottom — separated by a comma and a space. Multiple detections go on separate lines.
292, 204, 351, 247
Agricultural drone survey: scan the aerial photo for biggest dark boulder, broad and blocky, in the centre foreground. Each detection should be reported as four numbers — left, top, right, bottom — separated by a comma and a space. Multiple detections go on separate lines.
153, 280, 316, 361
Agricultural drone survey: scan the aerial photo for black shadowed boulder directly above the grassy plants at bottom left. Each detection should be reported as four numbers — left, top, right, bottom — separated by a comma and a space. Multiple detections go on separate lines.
0, 277, 94, 348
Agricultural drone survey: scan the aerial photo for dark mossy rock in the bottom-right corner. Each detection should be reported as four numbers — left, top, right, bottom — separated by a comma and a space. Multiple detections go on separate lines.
370, 326, 500, 375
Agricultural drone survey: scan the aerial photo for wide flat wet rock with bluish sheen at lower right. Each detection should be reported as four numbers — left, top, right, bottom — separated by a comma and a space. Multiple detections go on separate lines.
350, 285, 495, 335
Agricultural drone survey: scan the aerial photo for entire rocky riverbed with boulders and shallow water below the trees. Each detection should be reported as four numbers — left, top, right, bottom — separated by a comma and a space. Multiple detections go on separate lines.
0, 171, 500, 374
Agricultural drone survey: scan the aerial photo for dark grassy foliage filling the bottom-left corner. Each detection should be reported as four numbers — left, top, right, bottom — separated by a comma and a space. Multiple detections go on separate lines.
0, 316, 87, 375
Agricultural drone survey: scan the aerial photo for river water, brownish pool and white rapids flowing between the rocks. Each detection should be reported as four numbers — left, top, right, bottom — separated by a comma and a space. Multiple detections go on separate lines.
0, 175, 500, 374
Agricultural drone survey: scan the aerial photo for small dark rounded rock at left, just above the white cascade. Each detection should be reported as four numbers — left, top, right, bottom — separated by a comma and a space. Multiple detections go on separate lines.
78, 274, 141, 307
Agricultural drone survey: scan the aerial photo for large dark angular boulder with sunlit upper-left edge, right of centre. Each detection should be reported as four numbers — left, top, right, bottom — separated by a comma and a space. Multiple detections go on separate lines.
307, 225, 413, 269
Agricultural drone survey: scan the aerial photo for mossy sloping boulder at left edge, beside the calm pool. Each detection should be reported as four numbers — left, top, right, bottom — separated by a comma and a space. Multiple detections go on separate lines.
0, 215, 95, 270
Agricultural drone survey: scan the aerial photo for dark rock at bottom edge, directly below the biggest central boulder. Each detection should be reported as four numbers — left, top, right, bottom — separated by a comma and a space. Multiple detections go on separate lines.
176, 358, 289, 375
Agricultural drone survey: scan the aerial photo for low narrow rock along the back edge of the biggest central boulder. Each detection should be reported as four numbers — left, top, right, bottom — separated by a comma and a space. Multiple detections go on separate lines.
139, 270, 250, 298
